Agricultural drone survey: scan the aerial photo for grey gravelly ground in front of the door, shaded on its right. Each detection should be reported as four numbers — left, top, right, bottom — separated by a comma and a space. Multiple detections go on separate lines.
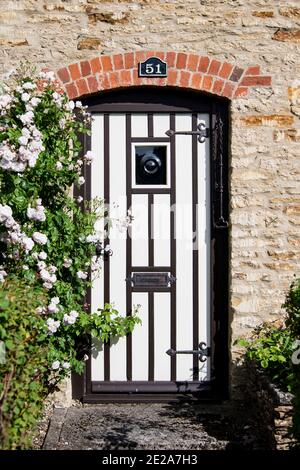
43, 403, 266, 450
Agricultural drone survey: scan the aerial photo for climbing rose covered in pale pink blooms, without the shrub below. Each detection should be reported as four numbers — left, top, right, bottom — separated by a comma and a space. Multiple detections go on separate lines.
0, 67, 139, 382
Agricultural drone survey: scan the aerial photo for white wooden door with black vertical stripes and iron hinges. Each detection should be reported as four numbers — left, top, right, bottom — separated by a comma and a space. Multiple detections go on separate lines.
90, 113, 211, 394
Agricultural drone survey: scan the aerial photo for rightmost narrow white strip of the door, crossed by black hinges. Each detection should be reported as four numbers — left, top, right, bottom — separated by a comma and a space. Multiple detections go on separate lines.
197, 114, 211, 380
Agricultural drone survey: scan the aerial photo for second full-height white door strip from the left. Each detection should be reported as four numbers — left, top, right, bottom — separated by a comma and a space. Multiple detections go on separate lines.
109, 114, 127, 380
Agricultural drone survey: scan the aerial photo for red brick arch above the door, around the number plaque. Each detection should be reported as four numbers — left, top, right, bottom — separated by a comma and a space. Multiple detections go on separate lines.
57, 51, 272, 99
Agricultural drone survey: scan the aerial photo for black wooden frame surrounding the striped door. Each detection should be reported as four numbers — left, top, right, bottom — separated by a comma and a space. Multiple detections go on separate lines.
75, 86, 229, 403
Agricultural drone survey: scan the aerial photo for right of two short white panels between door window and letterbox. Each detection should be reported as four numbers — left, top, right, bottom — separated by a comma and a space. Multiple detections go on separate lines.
152, 194, 171, 266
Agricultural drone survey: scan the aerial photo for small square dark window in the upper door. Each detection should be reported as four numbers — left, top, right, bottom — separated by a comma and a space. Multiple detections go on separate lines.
135, 145, 167, 185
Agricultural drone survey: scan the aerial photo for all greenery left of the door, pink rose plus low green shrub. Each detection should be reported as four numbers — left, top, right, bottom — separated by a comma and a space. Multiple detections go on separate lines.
0, 67, 139, 448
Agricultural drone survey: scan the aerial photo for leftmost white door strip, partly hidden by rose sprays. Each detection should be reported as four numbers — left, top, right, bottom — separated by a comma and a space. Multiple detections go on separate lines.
91, 114, 104, 381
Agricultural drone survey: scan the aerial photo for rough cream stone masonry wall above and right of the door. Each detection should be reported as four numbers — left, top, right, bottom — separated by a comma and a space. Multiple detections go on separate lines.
0, 0, 300, 390
